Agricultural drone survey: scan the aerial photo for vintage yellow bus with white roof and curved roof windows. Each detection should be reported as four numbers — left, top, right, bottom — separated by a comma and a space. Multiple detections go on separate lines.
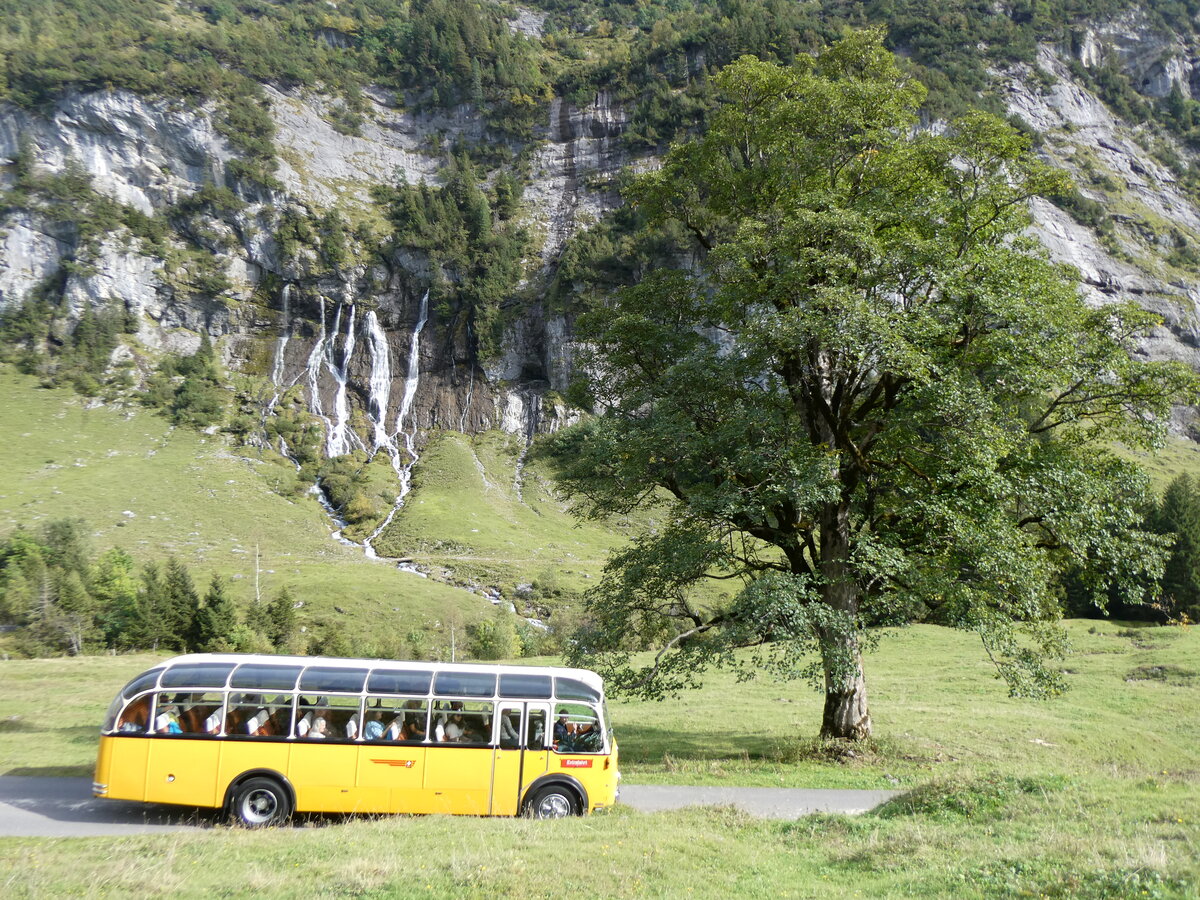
92, 654, 619, 827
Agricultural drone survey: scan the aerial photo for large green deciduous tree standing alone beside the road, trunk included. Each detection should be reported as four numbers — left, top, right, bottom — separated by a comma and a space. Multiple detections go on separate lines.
560, 32, 1194, 739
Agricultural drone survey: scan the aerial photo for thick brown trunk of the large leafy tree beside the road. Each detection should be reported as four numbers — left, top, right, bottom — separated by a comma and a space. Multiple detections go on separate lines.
817, 503, 871, 740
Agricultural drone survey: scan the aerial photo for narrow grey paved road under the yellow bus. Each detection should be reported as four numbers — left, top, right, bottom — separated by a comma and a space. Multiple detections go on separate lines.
0, 775, 898, 838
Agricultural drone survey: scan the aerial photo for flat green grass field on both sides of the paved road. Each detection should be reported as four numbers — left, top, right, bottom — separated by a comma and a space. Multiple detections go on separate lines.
0, 622, 1200, 898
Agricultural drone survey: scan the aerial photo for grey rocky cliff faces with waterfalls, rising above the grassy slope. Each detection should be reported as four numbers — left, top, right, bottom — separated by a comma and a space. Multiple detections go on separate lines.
7, 13, 1200, 454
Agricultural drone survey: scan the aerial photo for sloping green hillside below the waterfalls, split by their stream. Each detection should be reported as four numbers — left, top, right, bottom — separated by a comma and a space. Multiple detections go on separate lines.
0, 368, 620, 640
